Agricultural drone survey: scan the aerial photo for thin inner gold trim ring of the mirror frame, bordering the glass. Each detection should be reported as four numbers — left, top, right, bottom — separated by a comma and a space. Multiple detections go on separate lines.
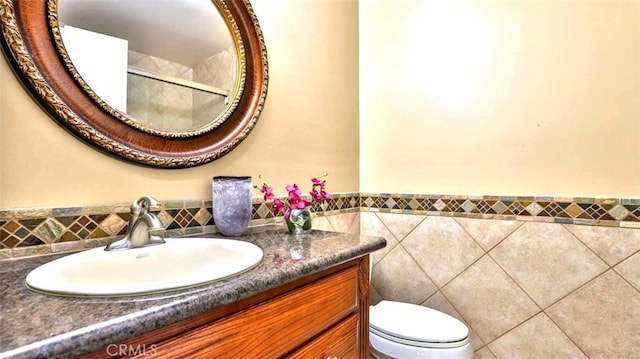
47, 0, 247, 138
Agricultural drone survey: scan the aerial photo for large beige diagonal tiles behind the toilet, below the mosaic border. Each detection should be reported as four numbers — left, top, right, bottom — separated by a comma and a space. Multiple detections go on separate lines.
359, 209, 640, 359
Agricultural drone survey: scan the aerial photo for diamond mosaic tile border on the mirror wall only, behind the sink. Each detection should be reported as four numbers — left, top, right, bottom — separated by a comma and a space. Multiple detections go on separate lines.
0, 193, 360, 259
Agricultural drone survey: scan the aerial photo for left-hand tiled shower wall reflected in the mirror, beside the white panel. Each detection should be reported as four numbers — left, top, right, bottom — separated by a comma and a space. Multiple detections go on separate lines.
127, 50, 194, 131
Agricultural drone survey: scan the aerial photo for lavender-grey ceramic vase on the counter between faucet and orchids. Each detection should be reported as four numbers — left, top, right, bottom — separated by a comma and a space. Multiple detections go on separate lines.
213, 176, 253, 237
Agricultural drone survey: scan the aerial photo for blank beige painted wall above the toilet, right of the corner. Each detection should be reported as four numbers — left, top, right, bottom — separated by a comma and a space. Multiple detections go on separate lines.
360, 0, 640, 198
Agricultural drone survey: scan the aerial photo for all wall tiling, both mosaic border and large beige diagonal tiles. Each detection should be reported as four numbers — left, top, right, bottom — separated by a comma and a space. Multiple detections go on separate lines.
0, 193, 640, 358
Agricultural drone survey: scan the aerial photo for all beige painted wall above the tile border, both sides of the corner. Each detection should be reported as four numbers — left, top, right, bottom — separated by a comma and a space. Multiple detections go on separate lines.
0, 0, 640, 208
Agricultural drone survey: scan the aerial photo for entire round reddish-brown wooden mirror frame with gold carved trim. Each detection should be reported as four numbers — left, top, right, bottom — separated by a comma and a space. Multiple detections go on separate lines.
0, 0, 268, 168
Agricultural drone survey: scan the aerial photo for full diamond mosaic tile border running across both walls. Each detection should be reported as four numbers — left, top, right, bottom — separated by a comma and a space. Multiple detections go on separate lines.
0, 193, 640, 259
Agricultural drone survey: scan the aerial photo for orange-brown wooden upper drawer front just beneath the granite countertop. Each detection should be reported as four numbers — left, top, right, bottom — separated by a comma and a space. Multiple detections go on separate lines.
144, 267, 358, 359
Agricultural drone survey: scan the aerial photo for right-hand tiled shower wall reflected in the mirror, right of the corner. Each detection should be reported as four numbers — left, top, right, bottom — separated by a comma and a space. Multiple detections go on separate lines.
193, 46, 235, 127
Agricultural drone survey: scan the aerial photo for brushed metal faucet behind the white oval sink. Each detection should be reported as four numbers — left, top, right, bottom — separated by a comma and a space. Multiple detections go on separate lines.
104, 196, 165, 251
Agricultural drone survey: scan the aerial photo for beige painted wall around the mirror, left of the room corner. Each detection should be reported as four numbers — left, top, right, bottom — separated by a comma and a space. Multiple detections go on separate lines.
0, 0, 359, 208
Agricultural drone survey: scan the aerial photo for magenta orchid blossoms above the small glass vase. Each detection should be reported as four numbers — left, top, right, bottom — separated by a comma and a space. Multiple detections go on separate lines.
253, 173, 331, 220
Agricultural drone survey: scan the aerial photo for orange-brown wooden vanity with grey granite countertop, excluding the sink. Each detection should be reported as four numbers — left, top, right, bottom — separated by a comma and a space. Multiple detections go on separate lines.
0, 226, 385, 358
